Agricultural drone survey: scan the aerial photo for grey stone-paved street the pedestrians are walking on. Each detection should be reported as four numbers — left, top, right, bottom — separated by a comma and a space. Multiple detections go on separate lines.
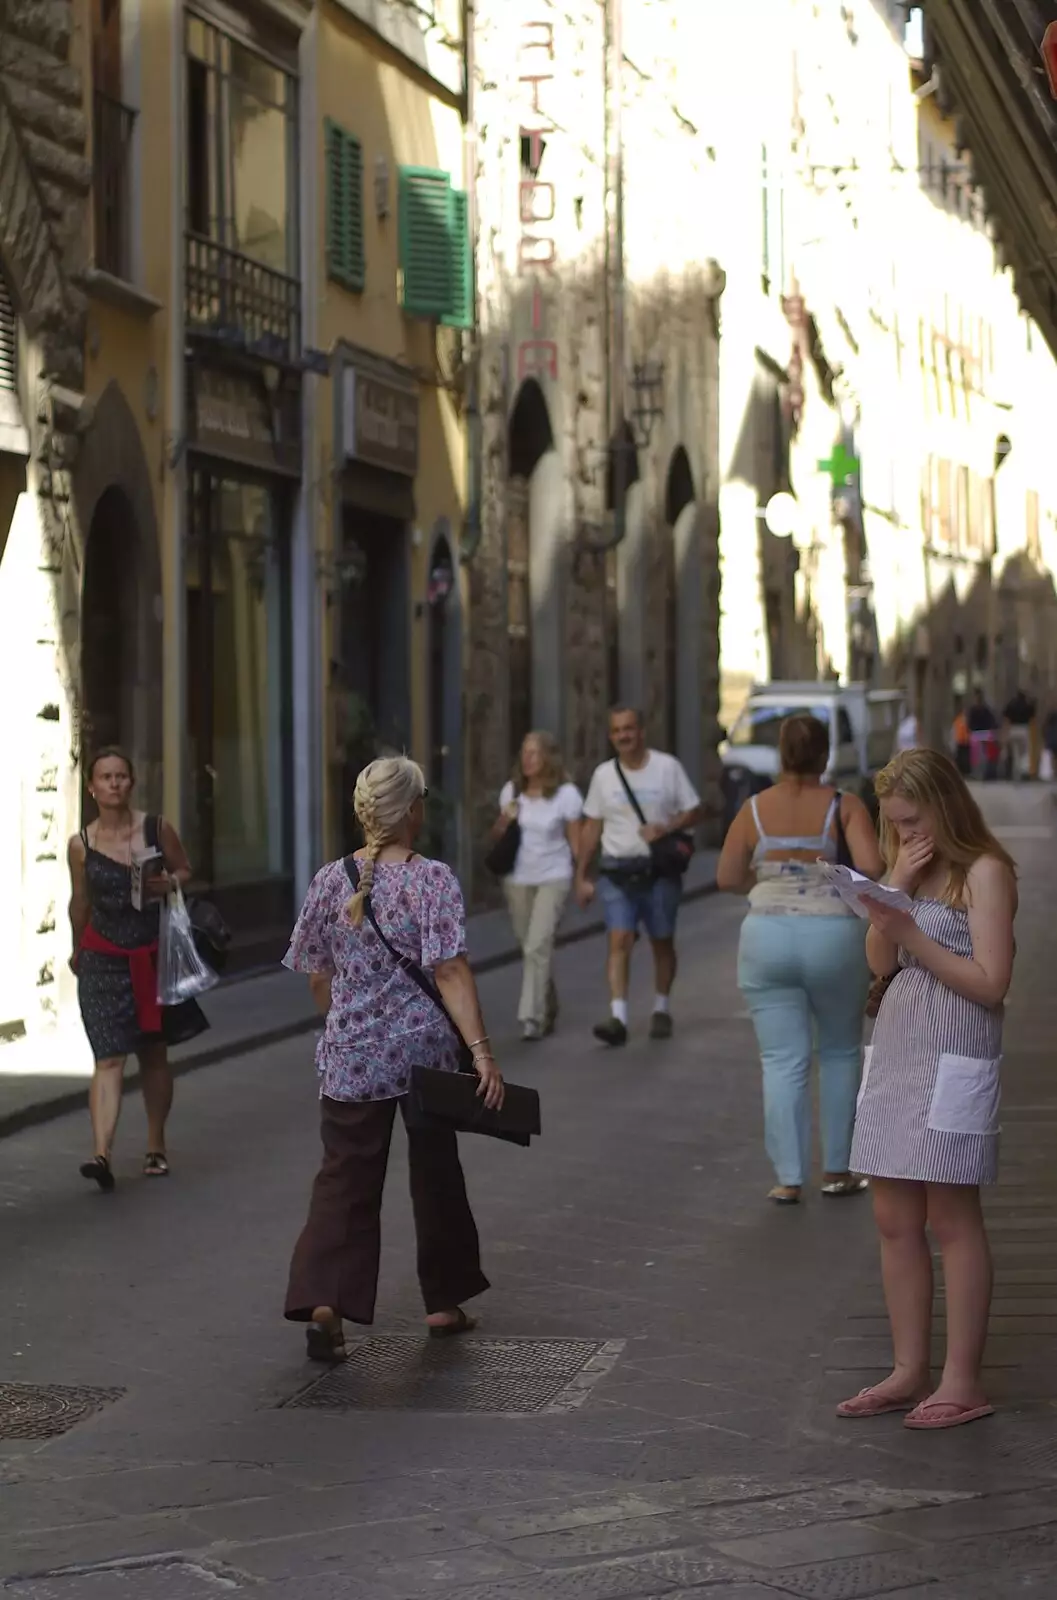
0, 787, 1057, 1600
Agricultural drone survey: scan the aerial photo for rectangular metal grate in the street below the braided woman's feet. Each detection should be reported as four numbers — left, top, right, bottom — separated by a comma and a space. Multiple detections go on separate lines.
286, 1336, 624, 1414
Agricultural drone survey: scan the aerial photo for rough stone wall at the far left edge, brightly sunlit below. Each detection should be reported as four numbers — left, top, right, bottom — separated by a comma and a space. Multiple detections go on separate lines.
0, 0, 90, 1030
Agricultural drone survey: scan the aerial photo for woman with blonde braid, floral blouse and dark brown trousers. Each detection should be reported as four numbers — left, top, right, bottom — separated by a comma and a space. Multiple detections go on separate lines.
286, 757, 504, 1362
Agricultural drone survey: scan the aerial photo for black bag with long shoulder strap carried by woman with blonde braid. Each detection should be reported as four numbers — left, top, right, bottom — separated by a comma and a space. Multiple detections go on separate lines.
345, 856, 540, 1149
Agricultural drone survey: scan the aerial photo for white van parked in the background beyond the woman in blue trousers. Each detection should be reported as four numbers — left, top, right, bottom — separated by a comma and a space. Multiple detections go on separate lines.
720, 682, 905, 832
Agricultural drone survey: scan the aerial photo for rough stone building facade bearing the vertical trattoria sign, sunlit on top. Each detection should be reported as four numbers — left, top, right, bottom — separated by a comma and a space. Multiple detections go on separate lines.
465, 0, 723, 891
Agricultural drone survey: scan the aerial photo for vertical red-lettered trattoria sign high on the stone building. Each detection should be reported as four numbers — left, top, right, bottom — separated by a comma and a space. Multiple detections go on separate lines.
518, 21, 558, 382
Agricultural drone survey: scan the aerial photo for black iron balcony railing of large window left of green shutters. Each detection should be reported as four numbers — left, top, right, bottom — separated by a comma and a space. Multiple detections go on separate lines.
184, 234, 301, 362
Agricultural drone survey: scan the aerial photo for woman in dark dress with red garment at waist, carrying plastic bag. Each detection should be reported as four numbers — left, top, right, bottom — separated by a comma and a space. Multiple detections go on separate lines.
67, 747, 208, 1192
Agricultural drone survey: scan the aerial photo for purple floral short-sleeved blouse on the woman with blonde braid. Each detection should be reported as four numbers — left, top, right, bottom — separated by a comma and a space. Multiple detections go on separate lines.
283, 856, 465, 1101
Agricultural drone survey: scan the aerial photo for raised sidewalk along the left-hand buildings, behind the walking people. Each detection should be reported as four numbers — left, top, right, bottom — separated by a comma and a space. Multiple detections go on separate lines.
0, 850, 718, 1139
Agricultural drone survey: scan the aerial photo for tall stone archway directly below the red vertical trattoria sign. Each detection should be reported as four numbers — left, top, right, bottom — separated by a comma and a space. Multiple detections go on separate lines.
507, 378, 564, 760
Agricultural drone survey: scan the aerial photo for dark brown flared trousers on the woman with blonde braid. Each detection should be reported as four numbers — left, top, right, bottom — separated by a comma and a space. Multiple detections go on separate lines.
286, 1096, 489, 1325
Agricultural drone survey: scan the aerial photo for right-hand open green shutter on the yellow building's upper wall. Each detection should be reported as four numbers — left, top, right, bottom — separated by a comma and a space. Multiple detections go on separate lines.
400, 166, 473, 328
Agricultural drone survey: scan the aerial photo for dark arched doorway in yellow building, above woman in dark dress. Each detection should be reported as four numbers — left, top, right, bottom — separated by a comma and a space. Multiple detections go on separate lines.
74, 382, 163, 810
